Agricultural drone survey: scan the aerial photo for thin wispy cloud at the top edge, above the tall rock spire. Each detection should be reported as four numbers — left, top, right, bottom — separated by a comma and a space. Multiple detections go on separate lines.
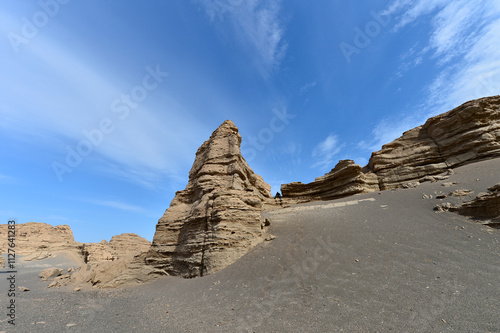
200, 0, 287, 77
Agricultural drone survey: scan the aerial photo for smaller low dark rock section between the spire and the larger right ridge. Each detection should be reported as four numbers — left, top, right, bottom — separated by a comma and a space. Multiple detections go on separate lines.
281, 160, 379, 201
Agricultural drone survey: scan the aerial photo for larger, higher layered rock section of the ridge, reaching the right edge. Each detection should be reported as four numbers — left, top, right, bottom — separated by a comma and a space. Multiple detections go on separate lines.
368, 96, 500, 190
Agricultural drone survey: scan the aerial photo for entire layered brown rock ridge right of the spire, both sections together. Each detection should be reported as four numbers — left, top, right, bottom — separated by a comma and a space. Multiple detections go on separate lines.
281, 96, 500, 201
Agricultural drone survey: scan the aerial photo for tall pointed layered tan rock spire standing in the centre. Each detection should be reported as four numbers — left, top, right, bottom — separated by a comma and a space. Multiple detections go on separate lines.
146, 120, 271, 277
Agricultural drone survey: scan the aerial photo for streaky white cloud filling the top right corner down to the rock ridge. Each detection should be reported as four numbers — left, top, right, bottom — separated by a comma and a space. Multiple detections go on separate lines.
358, 0, 500, 155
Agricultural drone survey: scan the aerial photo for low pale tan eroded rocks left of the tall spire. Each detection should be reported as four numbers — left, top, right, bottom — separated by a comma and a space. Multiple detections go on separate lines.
0, 222, 154, 287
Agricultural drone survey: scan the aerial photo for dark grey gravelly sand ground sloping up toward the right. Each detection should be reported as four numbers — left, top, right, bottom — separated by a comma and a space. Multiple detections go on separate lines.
0, 159, 500, 332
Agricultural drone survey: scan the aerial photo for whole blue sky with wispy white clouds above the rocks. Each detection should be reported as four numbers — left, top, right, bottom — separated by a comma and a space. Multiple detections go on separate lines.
0, 0, 500, 242
